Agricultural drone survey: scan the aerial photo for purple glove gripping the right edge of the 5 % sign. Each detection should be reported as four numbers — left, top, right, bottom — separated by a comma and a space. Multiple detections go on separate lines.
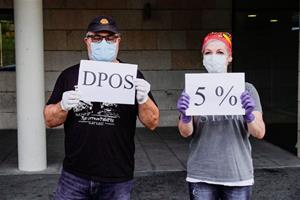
241, 90, 255, 123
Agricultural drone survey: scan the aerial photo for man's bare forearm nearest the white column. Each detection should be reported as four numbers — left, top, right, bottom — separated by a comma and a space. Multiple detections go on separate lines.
44, 102, 68, 128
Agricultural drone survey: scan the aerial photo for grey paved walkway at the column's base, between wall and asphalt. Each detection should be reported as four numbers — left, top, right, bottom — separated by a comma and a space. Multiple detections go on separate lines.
0, 127, 300, 175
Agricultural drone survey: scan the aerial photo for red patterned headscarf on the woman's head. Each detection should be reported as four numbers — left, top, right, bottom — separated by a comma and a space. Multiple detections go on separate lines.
202, 32, 232, 55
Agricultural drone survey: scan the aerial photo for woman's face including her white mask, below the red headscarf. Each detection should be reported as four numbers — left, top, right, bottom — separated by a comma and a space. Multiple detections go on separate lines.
203, 41, 231, 73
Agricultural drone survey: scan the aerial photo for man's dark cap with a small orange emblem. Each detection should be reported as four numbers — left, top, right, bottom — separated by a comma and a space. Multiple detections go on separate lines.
87, 16, 119, 33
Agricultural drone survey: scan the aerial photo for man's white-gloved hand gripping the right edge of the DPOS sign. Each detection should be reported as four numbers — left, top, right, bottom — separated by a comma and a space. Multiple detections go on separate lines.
135, 78, 151, 104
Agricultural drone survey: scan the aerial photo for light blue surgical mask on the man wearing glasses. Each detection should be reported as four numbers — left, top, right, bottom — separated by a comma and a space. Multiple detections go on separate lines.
91, 39, 117, 62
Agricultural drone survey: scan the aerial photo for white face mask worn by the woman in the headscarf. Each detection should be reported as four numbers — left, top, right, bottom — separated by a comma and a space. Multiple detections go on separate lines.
203, 54, 227, 73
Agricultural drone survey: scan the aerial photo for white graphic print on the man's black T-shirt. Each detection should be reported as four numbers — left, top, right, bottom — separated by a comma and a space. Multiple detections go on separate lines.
73, 101, 120, 126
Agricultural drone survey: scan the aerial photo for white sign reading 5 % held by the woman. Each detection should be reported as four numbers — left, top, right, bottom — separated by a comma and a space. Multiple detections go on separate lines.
185, 73, 245, 115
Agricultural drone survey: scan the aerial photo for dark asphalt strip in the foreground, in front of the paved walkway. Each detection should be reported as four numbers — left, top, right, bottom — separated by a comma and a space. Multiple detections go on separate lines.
0, 168, 300, 200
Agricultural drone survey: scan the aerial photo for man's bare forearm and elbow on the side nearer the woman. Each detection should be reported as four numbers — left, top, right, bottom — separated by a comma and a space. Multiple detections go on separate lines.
139, 98, 159, 130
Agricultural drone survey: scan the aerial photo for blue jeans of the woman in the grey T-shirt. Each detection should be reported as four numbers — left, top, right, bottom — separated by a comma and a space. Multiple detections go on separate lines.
189, 183, 252, 200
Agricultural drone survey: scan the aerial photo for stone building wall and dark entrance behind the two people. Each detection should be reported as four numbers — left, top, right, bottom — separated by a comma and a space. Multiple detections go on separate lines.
0, 0, 300, 154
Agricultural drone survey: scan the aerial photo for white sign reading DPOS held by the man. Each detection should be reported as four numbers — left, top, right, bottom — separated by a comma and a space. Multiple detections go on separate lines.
78, 60, 137, 104
